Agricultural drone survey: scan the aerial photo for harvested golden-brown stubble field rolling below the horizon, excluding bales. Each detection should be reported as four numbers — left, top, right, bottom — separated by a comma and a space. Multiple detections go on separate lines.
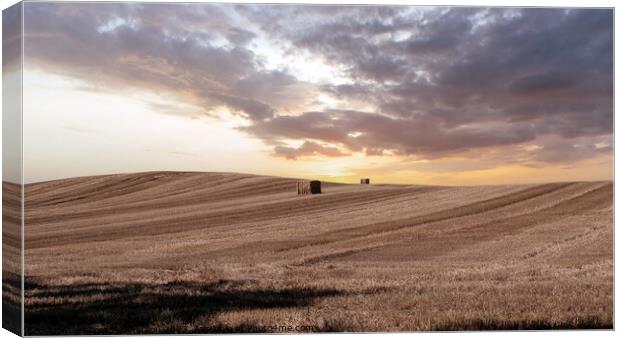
20, 172, 613, 335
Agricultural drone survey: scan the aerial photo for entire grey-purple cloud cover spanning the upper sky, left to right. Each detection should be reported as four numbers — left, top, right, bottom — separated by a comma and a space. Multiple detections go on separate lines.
26, 3, 613, 162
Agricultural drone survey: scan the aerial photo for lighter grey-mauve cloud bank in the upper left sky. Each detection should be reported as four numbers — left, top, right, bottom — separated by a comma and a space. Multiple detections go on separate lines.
25, 3, 314, 120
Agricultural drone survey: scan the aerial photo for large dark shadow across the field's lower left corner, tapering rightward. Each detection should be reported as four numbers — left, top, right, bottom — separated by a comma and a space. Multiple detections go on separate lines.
25, 280, 345, 335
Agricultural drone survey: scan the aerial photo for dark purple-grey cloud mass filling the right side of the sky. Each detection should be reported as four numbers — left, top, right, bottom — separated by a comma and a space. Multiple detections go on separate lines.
240, 7, 613, 162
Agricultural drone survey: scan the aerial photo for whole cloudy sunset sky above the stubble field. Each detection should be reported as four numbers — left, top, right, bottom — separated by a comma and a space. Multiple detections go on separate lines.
12, 2, 613, 185
